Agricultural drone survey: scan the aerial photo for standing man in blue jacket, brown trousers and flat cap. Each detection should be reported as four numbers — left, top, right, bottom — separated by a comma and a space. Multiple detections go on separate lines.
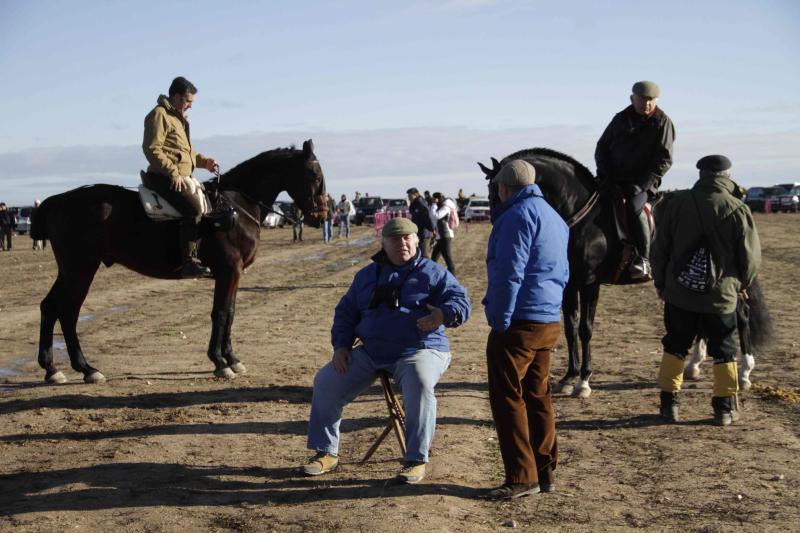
483, 159, 569, 500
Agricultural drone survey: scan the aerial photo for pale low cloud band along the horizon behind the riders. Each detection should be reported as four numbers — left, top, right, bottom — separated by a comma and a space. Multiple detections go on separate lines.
0, 126, 800, 205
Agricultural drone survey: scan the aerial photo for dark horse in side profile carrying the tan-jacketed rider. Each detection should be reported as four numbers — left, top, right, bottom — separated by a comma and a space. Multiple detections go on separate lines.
31, 140, 327, 383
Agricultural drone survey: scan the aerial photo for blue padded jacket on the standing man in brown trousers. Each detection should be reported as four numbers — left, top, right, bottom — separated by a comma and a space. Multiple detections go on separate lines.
483, 185, 569, 331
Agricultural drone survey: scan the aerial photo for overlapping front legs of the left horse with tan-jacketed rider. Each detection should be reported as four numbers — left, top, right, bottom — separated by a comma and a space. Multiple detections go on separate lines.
208, 270, 241, 379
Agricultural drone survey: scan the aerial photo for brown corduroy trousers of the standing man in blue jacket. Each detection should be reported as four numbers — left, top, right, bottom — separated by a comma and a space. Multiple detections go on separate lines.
486, 321, 561, 484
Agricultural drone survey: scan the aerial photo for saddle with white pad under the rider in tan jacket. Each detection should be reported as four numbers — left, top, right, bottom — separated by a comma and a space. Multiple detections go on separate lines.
138, 171, 239, 232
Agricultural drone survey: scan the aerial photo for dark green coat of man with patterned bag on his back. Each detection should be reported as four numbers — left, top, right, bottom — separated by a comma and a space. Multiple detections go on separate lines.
650, 177, 761, 314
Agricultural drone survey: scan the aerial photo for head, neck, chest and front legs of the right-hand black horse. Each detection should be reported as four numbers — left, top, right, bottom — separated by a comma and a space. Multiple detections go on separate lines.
478, 148, 656, 398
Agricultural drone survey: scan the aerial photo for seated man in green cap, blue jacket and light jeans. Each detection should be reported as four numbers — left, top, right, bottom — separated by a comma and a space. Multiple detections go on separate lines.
303, 218, 471, 483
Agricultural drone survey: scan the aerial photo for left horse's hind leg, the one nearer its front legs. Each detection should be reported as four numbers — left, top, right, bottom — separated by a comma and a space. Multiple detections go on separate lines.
57, 259, 106, 383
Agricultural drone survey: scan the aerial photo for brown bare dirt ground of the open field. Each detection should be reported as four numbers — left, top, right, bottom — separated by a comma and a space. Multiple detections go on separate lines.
0, 215, 800, 532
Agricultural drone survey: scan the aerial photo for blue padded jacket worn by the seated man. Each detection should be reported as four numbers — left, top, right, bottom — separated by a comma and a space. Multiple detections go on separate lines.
331, 251, 471, 364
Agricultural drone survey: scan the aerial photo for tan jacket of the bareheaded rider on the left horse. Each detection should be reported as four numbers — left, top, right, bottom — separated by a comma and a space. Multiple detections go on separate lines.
142, 94, 206, 181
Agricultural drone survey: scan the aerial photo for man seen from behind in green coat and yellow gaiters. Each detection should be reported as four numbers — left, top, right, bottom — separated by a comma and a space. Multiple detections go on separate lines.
650, 155, 761, 426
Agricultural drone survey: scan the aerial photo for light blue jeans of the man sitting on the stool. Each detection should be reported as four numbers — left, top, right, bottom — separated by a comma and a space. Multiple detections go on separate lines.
308, 346, 450, 462
